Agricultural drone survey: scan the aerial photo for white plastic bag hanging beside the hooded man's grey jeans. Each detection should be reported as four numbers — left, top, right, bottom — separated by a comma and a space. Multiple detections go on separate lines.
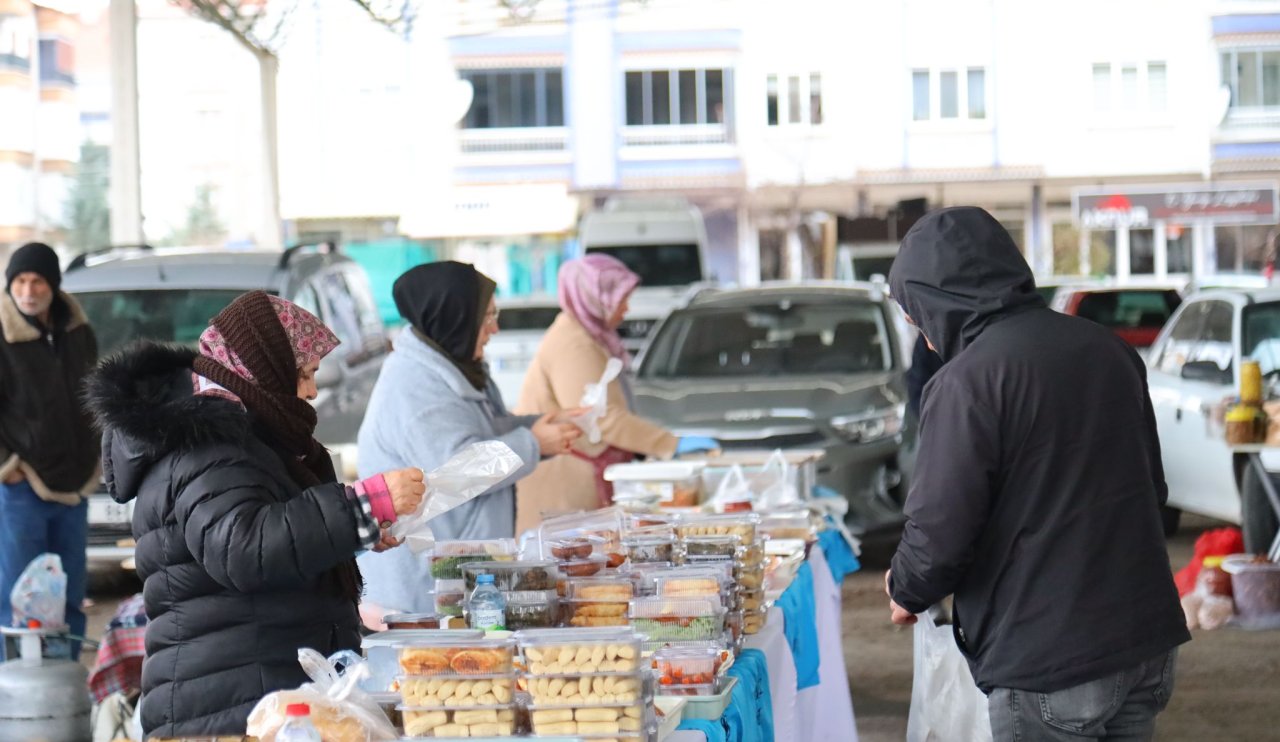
906, 609, 991, 742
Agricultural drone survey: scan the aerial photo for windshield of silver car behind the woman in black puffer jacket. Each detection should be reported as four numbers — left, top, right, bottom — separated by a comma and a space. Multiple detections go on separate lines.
76, 289, 244, 356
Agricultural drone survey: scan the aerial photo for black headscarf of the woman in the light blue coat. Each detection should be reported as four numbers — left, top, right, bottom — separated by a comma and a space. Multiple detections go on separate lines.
392, 261, 498, 390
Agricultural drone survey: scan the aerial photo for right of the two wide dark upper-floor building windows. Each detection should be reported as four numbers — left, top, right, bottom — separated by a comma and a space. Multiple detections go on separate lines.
625, 69, 727, 127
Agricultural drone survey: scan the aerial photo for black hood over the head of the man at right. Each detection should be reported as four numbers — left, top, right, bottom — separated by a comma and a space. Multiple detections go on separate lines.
888, 206, 1044, 361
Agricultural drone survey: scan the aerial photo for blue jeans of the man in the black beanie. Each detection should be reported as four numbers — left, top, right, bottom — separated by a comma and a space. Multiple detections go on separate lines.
0, 481, 88, 659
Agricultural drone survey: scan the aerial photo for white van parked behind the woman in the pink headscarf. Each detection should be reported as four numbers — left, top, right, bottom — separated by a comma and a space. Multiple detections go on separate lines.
579, 196, 707, 353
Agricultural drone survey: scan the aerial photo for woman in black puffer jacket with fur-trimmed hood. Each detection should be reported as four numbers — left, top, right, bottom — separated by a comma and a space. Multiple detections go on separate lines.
87, 292, 424, 737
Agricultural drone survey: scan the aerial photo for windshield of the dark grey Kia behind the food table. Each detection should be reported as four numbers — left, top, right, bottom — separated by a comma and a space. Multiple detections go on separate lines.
640, 299, 893, 379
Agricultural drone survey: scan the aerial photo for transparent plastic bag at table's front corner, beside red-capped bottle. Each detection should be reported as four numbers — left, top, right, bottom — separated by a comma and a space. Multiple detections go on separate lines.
247, 649, 399, 742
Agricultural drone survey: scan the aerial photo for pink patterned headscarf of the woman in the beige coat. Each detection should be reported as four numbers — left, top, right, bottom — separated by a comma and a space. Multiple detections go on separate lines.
559, 252, 640, 367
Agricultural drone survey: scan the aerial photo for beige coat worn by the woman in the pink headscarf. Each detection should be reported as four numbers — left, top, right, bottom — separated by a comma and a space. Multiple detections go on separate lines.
516, 312, 676, 533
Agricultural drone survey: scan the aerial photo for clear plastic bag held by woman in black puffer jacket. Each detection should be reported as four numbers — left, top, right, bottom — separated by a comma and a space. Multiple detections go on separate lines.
390, 440, 525, 551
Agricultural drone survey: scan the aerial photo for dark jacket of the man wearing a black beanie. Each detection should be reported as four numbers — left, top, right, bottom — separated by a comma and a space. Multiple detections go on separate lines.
0, 293, 99, 505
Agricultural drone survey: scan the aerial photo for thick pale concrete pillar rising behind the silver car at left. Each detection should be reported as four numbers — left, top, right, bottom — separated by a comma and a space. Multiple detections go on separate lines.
110, 0, 145, 244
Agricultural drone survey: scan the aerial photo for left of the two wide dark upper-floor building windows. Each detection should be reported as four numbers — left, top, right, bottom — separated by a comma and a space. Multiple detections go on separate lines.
458, 69, 563, 129
